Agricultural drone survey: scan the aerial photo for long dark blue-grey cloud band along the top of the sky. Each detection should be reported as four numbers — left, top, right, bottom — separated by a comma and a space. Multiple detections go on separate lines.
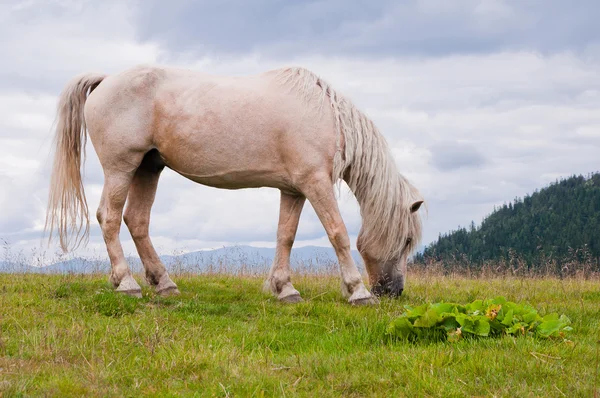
131, 0, 600, 56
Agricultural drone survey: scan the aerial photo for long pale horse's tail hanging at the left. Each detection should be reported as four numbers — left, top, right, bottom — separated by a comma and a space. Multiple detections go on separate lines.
44, 74, 106, 252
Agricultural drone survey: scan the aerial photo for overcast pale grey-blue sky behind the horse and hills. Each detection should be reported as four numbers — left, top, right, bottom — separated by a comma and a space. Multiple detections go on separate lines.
0, 0, 600, 264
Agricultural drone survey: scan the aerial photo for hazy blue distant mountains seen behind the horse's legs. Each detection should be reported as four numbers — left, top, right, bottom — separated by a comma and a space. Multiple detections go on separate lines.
0, 246, 363, 273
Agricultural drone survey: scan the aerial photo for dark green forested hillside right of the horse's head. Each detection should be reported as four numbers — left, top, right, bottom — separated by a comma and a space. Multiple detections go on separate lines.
415, 173, 600, 267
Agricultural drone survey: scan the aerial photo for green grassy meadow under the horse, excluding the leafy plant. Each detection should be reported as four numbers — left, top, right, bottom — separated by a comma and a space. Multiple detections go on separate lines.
0, 274, 600, 397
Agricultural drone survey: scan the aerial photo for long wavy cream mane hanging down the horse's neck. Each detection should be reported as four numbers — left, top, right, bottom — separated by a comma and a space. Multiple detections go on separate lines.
277, 67, 421, 260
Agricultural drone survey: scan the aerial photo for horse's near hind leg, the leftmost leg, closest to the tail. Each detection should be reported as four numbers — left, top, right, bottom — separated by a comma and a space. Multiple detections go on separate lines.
96, 163, 142, 297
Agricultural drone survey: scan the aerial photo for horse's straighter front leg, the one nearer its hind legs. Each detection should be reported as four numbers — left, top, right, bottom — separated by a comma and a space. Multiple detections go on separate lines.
265, 192, 306, 303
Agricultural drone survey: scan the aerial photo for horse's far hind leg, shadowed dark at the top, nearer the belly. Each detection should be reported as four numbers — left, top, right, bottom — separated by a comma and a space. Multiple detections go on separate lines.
123, 151, 179, 296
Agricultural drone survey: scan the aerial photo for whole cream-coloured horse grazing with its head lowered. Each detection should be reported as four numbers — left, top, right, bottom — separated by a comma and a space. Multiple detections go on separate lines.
46, 66, 423, 304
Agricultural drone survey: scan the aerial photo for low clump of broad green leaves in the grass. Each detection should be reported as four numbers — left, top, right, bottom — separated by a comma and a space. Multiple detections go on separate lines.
387, 297, 573, 342
